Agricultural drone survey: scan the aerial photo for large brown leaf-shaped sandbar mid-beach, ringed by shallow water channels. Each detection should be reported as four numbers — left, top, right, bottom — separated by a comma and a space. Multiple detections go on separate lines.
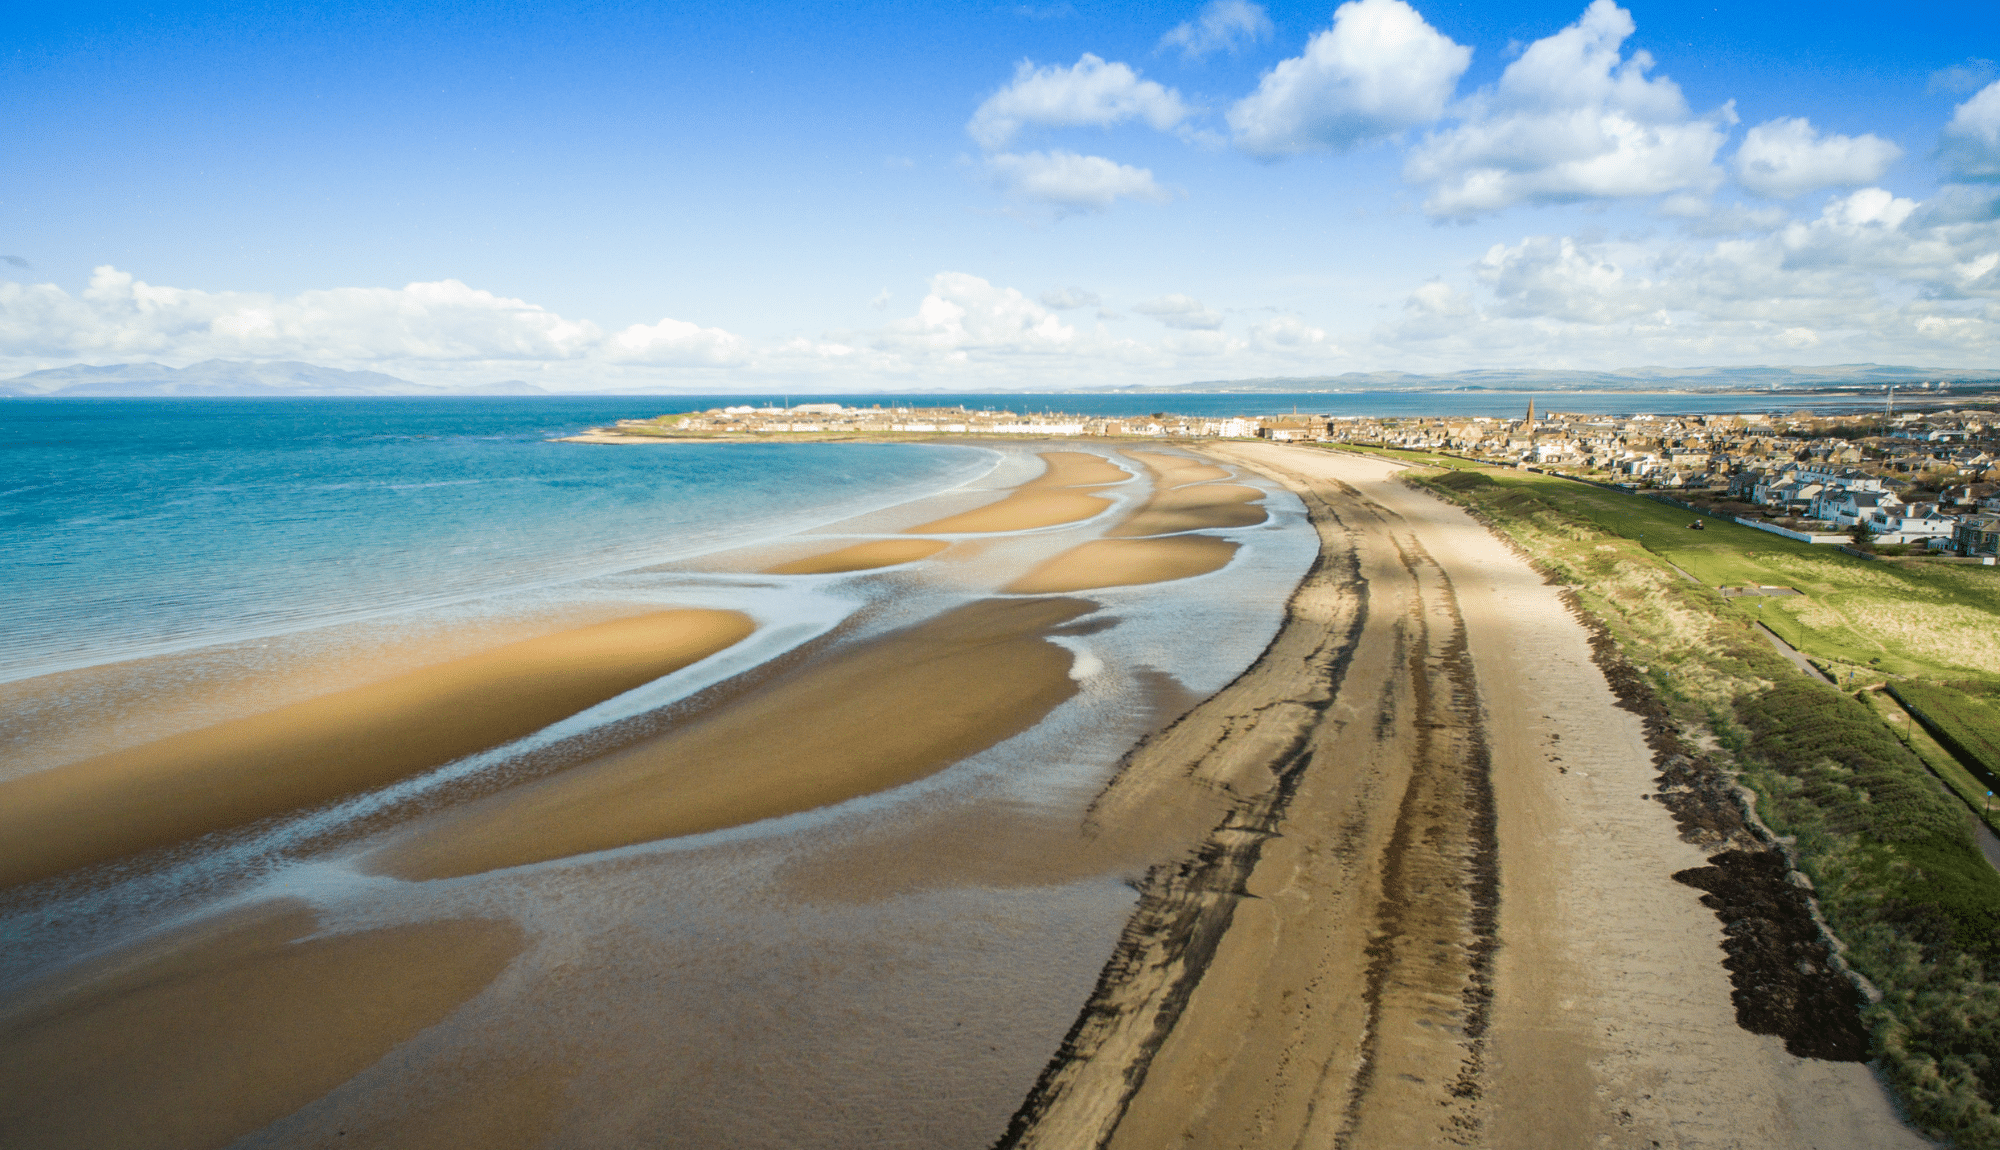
362, 598, 1096, 880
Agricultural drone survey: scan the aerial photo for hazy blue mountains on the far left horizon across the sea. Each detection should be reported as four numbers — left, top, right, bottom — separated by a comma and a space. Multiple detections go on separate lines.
0, 360, 550, 398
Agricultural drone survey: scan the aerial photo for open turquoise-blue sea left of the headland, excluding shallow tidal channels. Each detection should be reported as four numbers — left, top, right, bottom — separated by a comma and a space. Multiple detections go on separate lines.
0, 398, 994, 682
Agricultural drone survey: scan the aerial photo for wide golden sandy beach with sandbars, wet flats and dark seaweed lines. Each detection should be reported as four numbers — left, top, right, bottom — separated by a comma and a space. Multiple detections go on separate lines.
0, 436, 1922, 1150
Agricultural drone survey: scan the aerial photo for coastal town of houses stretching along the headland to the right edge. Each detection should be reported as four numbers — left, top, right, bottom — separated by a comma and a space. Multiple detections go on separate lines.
604, 400, 2000, 560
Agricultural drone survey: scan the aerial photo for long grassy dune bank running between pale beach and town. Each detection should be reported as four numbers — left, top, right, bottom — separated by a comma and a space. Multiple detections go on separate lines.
1414, 468, 2000, 1148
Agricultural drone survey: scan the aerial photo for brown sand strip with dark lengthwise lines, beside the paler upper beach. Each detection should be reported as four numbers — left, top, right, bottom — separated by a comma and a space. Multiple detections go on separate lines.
1000, 460, 1498, 1148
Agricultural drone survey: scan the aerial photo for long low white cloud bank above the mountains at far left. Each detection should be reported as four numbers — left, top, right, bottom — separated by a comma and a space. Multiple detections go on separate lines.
0, 266, 744, 364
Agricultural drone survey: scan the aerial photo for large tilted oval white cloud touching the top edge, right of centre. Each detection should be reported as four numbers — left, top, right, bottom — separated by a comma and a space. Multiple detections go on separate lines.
1228, 0, 1472, 158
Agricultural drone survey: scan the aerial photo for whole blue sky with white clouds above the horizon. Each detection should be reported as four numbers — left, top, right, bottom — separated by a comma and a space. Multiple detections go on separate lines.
0, 0, 2000, 390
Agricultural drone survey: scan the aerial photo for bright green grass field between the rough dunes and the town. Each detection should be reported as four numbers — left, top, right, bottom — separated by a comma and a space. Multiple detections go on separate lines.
1344, 452, 2000, 682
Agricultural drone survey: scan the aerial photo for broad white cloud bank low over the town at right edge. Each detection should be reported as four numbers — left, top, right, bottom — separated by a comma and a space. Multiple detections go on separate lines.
1376, 188, 2000, 366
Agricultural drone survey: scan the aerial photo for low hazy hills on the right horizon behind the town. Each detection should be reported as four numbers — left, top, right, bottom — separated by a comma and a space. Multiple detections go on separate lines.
1144, 364, 2000, 392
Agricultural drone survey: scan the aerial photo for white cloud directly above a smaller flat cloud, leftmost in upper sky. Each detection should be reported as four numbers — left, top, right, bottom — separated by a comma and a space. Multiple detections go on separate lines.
966, 52, 1190, 150
